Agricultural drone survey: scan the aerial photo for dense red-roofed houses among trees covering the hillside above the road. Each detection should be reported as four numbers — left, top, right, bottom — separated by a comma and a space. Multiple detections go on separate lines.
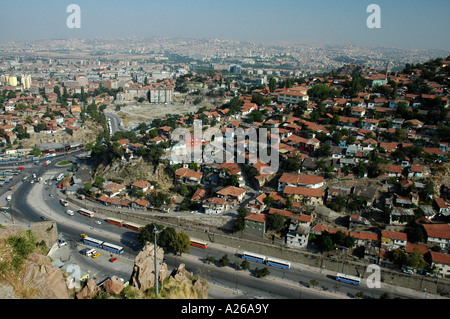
0, 57, 450, 278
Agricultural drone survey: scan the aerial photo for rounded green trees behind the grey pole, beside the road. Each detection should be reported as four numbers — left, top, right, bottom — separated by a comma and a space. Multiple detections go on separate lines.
136, 223, 191, 255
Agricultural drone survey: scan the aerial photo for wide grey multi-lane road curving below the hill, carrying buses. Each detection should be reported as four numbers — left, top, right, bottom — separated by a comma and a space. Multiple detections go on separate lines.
0, 154, 436, 299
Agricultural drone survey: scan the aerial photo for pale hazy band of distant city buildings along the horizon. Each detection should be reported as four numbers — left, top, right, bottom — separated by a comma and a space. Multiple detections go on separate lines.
0, 37, 448, 75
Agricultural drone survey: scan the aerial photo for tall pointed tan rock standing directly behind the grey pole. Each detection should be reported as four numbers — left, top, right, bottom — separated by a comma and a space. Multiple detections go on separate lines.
130, 243, 167, 291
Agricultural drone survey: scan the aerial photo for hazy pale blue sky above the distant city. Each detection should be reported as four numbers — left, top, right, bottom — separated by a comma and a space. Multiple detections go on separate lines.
0, 0, 450, 50
